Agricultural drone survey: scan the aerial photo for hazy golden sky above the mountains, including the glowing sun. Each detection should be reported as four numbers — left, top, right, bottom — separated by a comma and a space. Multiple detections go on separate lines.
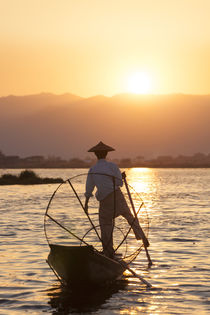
0, 0, 210, 97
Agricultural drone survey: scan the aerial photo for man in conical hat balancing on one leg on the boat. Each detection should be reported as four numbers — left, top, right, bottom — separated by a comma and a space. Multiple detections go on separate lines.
84, 142, 146, 258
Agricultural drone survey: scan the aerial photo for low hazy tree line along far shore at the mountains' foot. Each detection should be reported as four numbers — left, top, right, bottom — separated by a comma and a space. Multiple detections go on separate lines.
0, 151, 210, 169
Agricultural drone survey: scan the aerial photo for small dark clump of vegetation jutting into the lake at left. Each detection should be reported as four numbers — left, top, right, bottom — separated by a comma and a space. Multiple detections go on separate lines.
0, 170, 63, 185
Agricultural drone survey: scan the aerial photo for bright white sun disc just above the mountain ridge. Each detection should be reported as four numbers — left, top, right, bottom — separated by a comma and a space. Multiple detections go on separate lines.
126, 72, 152, 94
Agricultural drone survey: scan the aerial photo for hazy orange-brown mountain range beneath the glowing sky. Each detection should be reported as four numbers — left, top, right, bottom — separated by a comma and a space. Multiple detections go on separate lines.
0, 93, 210, 158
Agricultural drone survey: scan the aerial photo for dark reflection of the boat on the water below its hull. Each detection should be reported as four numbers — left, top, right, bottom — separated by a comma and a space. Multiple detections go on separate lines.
48, 280, 128, 314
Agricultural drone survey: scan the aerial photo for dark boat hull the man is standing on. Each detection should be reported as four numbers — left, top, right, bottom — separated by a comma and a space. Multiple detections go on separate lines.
48, 244, 126, 286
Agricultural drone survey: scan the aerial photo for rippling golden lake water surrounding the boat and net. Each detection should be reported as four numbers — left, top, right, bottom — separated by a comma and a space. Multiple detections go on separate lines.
0, 168, 210, 315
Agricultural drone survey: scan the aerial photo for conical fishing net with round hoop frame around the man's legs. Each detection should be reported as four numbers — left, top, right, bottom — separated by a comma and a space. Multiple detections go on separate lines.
44, 174, 149, 263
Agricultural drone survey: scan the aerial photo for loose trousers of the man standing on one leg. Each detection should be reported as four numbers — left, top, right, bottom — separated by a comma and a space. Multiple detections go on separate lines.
99, 189, 142, 257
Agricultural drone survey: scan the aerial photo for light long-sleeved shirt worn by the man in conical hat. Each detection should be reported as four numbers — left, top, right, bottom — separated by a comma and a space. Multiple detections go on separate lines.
85, 159, 123, 201
